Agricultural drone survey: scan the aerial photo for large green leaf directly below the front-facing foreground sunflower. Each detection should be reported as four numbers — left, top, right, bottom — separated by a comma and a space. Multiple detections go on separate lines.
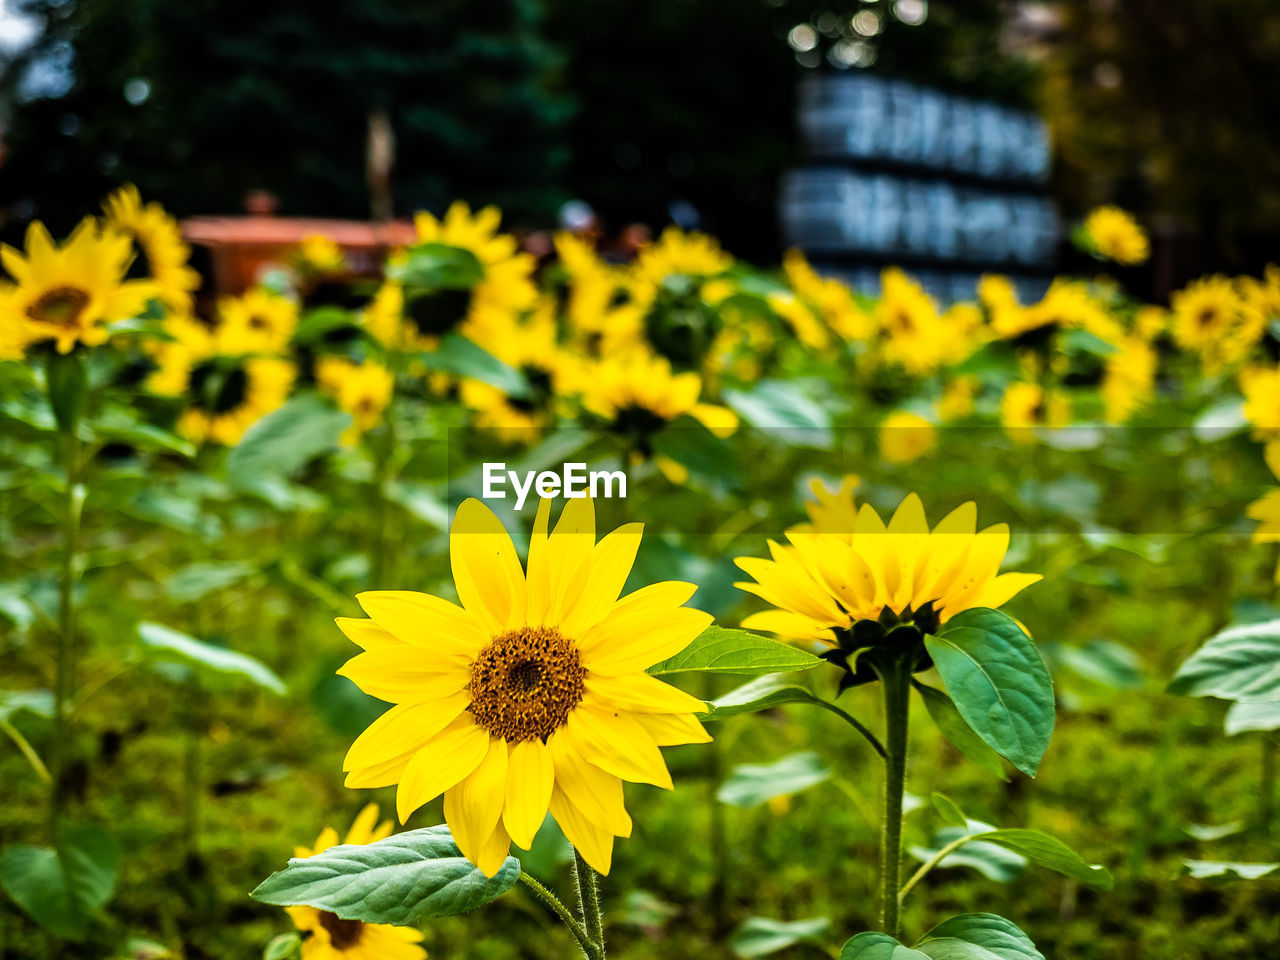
252, 826, 520, 925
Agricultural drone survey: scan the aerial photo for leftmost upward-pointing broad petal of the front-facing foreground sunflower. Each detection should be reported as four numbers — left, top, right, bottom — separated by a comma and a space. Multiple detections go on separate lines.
449, 498, 527, 634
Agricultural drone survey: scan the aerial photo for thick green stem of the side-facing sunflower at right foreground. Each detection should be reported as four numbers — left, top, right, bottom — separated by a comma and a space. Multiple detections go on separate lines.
876, 655, 913, 937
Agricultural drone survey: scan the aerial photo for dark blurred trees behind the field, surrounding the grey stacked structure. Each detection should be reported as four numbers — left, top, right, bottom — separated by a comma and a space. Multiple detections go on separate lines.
0, 0, 1280, 284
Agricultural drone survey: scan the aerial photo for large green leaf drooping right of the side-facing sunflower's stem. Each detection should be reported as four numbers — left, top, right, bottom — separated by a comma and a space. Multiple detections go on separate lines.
924, 607, 1053, 777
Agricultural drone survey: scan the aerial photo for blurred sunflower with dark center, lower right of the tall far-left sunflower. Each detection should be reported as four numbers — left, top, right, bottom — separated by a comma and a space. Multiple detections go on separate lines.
147, 316, 294, 445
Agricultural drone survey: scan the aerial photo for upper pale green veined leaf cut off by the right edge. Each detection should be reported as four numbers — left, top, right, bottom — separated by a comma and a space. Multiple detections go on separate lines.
1169, 620, 1280, 700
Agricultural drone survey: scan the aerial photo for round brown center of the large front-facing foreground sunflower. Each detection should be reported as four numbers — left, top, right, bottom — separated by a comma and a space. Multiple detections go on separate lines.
468, 627, 586, 742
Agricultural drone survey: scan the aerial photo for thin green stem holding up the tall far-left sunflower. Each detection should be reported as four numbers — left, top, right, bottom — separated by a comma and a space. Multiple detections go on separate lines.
49, 428, 84, 844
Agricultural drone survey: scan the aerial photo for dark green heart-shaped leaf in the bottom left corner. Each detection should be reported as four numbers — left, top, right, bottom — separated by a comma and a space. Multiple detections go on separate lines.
0, 823, 120, 941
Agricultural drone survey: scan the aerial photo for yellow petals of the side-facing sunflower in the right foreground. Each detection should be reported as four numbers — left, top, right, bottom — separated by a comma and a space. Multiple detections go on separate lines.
735, 493, 1041, 644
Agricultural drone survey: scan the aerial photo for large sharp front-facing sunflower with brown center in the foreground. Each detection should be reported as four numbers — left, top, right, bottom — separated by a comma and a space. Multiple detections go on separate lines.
338, 498, 712, 877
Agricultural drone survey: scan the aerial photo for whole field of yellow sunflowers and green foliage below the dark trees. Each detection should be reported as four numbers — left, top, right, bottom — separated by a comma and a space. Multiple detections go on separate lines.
0, 186, 1280, 960
